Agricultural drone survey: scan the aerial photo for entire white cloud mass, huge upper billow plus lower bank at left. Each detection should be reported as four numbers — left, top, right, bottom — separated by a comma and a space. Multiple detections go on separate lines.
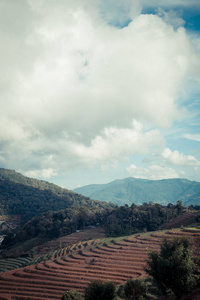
0, 0, 196, 176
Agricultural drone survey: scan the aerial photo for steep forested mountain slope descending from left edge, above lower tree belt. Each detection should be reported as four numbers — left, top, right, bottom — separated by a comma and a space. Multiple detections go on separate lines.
0, 168, 114, 223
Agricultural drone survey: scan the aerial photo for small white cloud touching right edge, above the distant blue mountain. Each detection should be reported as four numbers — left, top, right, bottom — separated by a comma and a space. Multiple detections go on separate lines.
161, 148, 200, 167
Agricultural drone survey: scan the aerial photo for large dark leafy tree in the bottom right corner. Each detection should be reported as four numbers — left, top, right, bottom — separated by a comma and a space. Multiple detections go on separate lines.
145, 238, 199, 299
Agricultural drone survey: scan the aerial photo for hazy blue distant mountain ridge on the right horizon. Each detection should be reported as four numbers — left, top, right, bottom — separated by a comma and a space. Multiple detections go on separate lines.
74, 177, 200, 206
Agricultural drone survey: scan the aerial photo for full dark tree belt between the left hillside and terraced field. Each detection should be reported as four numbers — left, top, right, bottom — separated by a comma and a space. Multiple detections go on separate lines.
1, 201, 184, 249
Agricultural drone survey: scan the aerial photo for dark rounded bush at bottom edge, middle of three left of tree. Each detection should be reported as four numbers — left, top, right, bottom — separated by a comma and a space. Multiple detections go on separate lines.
85, 280, 117, 300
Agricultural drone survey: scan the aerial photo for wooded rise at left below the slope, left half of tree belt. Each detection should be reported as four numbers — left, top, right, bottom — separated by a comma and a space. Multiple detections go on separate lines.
2, 206, 108, 248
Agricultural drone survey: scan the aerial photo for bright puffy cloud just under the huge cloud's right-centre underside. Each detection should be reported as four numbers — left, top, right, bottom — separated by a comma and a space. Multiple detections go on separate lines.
73, 121, 164, 163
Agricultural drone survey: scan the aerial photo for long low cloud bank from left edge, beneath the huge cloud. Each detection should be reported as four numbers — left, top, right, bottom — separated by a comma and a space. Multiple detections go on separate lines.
0, 121, 164, 178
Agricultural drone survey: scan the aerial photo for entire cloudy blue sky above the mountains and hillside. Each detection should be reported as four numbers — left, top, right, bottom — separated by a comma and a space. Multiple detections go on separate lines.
0, 0, 200, 189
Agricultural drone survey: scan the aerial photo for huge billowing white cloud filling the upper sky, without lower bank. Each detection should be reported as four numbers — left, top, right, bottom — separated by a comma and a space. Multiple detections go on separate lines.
2, 1, 193, 135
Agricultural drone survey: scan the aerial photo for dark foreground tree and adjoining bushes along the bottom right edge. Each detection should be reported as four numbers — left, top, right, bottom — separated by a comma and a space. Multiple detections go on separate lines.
59, 238, 200, 300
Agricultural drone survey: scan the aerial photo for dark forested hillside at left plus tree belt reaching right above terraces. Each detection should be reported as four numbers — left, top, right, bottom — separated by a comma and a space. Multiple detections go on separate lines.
0, 169, 198, 254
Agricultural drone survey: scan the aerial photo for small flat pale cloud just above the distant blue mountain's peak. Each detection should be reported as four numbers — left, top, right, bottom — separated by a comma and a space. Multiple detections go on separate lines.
127, 164, 179, 180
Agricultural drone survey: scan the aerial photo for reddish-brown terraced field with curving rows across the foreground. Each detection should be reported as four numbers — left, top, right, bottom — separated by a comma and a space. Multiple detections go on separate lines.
0, 230, 200, 300
